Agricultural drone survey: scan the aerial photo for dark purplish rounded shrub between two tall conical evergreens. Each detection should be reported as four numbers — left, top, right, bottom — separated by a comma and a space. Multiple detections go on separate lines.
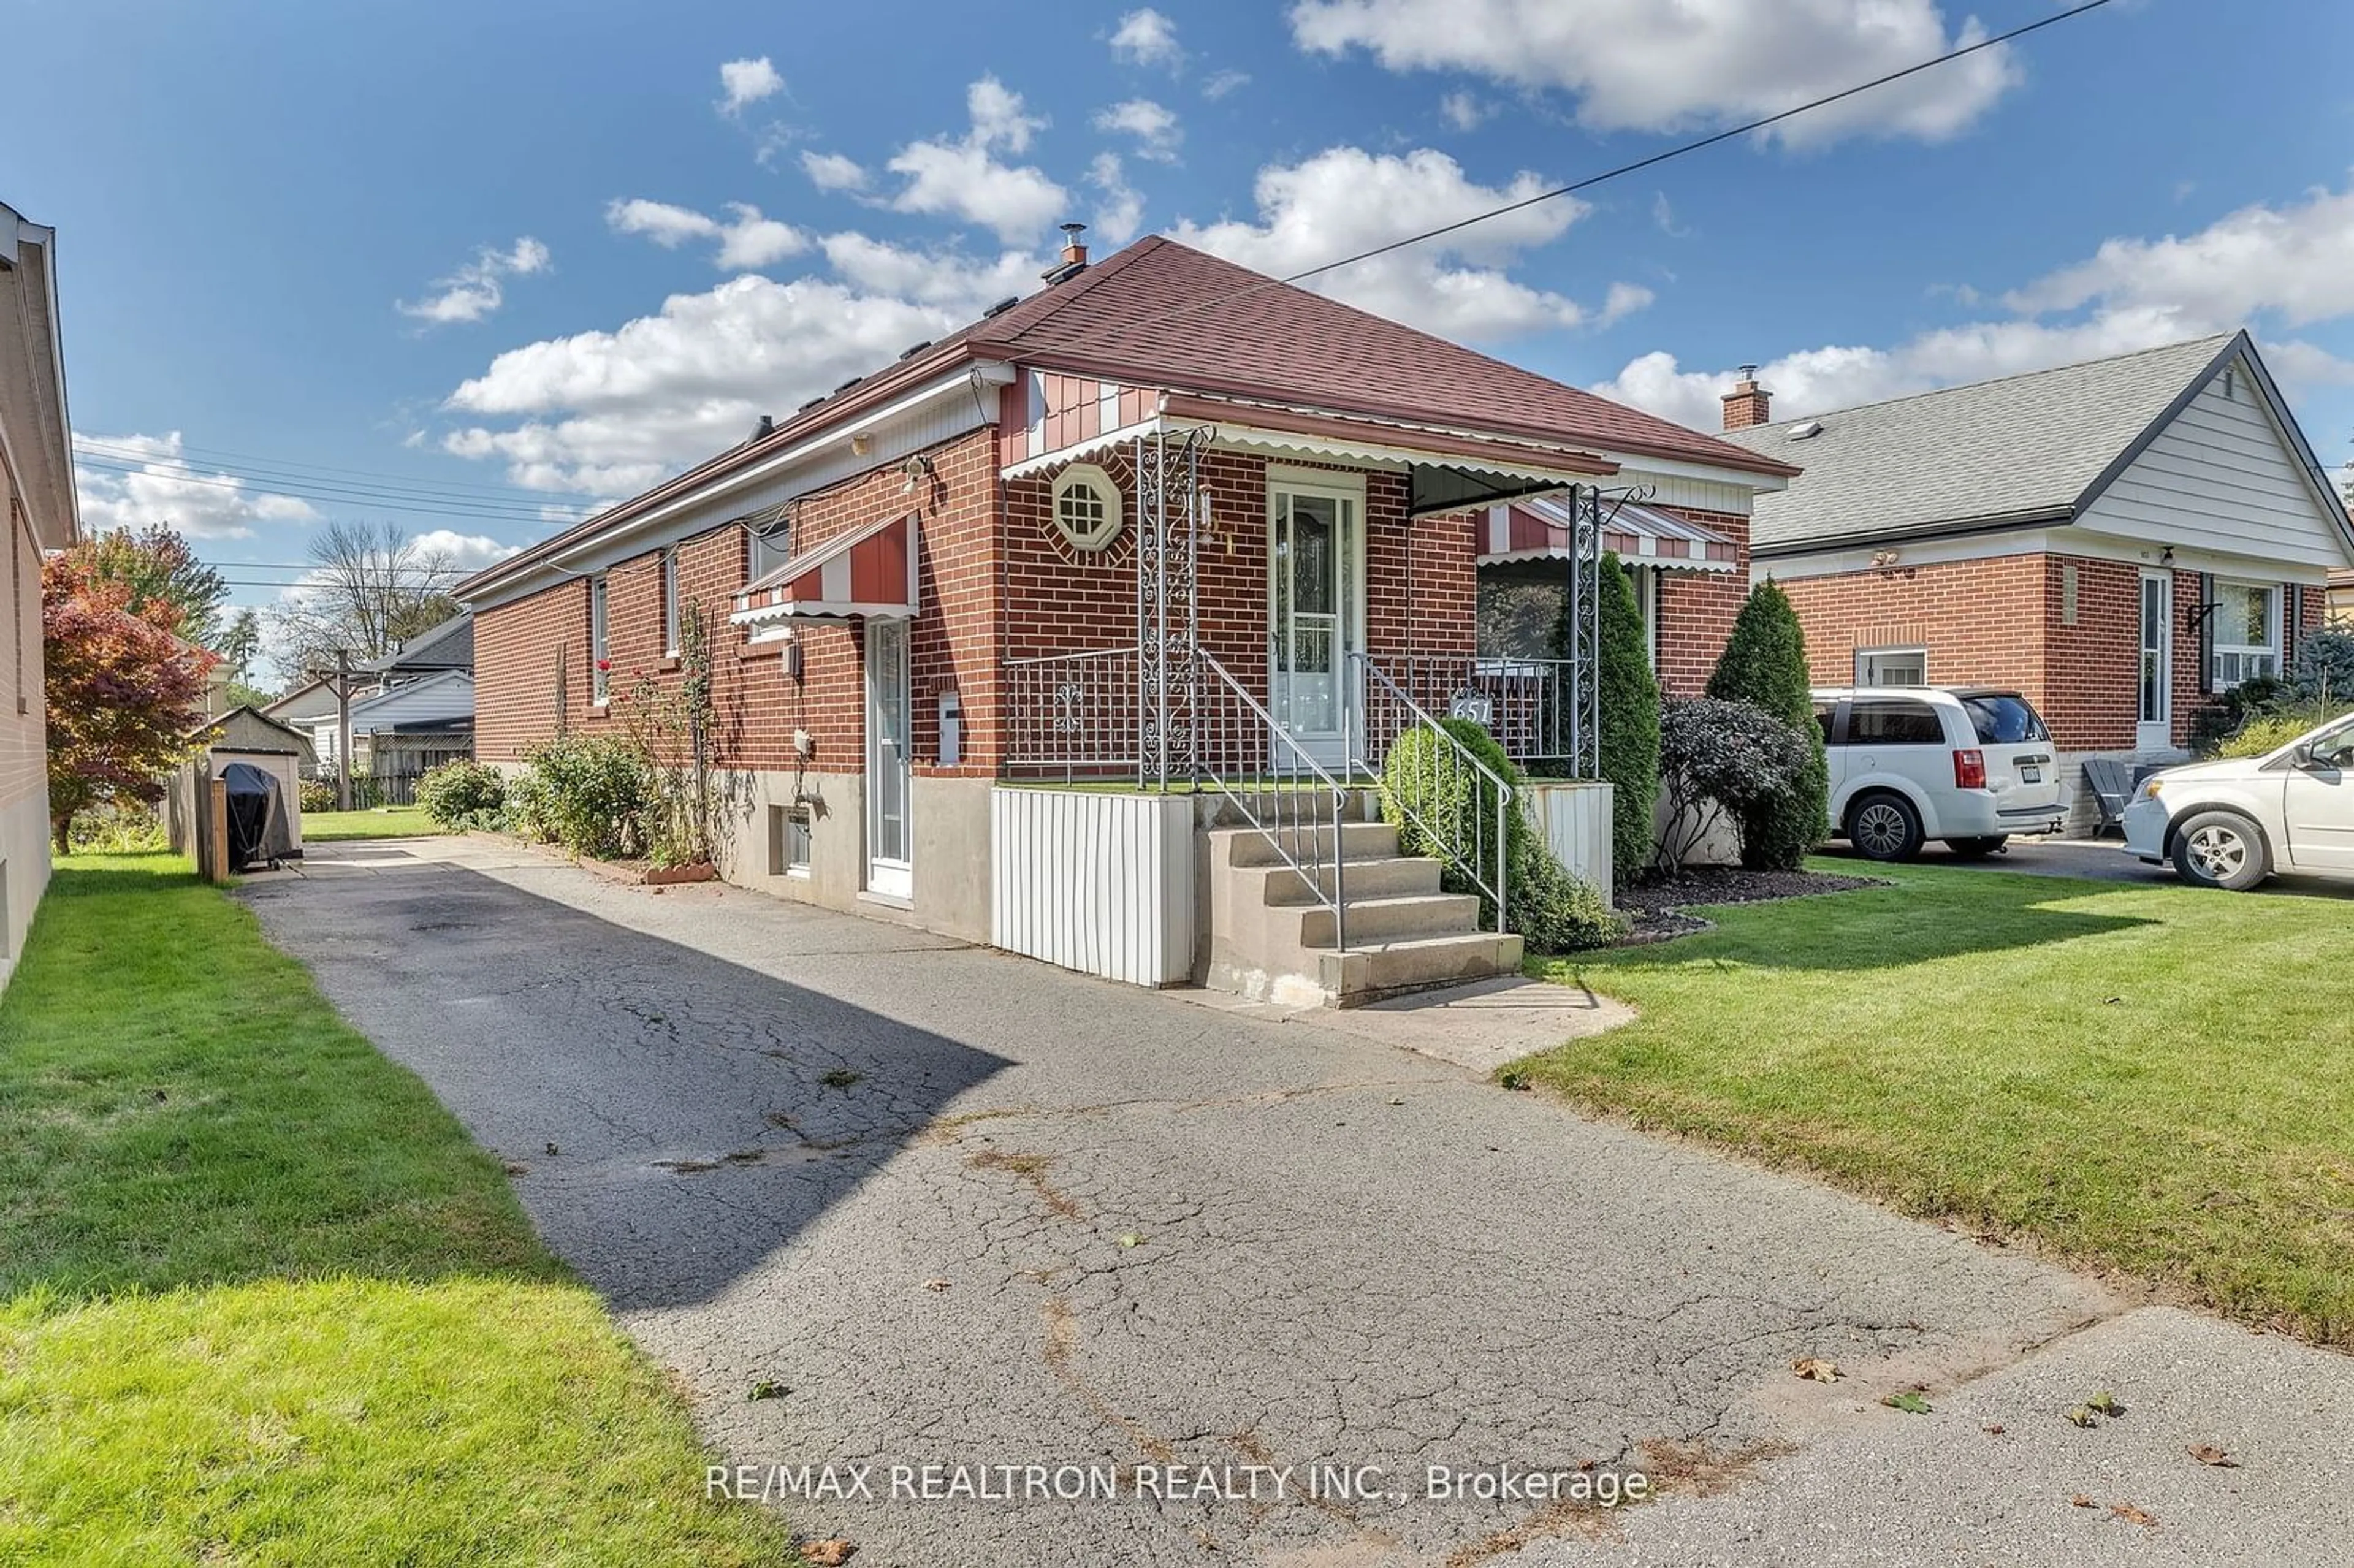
1659, 697, 1822, 876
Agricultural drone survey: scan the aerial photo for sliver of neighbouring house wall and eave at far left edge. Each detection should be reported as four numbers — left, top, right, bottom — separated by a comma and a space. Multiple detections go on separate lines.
0, 205, 80, 984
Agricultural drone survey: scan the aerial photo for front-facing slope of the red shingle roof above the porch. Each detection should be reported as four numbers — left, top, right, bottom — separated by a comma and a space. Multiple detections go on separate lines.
970, 235, 1796, 473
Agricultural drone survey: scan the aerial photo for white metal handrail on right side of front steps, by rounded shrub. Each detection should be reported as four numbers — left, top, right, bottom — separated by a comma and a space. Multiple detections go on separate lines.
1349, 652, 1516, 935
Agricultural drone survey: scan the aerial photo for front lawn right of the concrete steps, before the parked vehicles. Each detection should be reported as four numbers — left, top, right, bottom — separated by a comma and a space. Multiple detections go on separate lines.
1509, 864, 2354, 1344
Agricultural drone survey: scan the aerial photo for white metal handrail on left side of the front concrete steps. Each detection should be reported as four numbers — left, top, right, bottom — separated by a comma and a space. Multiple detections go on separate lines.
1194, 650, 1349, 951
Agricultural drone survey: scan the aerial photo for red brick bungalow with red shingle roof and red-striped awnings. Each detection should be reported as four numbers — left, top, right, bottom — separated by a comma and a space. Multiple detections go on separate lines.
459, 238, 1796, 980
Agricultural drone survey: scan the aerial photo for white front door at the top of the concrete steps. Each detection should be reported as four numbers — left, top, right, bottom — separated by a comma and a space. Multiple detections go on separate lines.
1267, 481, 1365, 770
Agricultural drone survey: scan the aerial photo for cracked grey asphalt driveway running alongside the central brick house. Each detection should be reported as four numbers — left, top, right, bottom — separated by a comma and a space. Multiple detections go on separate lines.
240, 840, 2354, 1568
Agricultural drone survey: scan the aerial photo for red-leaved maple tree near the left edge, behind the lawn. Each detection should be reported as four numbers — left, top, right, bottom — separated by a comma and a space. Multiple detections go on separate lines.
40, 549, 216, 850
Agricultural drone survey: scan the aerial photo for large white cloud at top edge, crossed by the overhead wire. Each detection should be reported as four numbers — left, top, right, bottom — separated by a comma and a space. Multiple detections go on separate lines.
1290, 0, 2020, 143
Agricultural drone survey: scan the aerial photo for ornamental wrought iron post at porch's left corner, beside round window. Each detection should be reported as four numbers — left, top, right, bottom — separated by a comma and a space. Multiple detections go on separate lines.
1135, 428, 1208, 789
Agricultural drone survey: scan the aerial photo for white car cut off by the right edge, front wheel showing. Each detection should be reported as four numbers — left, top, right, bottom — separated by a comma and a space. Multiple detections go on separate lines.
2126, 714, 2354, 892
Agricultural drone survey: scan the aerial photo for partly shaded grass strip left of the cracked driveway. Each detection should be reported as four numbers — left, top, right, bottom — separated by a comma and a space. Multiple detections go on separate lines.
0, 854, 787, 1568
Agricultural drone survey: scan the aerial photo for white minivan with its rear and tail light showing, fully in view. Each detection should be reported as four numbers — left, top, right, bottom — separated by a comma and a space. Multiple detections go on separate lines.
1815, 685, 2065, 859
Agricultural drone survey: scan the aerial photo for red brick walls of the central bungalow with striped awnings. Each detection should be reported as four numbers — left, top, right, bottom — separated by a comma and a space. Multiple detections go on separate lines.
476, 431, 1476, 775
